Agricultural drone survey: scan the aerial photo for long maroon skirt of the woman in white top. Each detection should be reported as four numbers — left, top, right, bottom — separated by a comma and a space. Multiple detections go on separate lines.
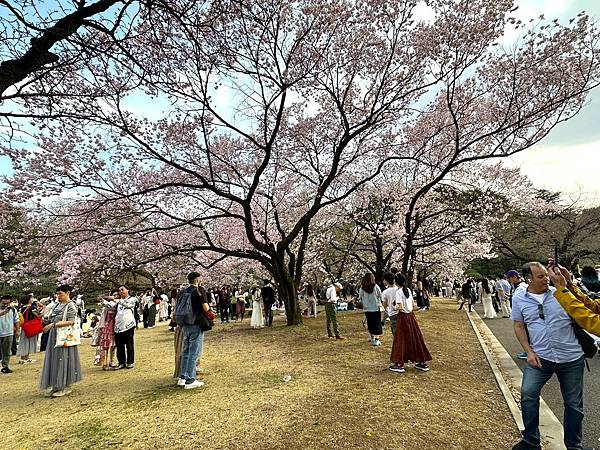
390, 312, 432, 365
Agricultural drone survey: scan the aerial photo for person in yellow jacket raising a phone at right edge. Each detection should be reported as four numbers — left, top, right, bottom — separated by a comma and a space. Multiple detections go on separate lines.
548, 265, 600, 336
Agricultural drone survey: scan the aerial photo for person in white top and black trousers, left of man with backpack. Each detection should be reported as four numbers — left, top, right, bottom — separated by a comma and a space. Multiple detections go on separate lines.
114, 285, 136, 370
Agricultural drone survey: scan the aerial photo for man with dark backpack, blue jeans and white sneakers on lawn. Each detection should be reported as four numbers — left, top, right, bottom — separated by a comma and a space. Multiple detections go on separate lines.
177, 272, 209, 389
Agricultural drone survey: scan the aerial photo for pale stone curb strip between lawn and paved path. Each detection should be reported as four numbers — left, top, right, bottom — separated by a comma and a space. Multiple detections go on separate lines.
465, 310, 565, 450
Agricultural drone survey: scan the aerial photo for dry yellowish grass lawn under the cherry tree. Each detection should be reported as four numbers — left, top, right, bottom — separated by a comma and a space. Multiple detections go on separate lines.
0, 299, 518, 450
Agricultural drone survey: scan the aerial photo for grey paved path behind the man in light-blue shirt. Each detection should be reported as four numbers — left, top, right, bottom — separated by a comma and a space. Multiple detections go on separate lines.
476, 304, 600, 448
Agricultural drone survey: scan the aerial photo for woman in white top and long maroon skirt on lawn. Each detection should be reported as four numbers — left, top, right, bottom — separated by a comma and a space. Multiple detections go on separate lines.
390, 274, 431, 373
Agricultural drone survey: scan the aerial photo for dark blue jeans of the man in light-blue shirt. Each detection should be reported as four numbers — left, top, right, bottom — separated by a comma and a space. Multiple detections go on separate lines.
521, 356, 585, 449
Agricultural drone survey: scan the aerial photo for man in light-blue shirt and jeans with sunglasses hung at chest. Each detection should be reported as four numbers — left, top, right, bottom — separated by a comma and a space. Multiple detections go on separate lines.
511, 262, 585, 450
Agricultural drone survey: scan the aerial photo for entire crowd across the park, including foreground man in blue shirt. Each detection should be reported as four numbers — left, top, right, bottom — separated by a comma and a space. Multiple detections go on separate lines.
0, 259, 600, 449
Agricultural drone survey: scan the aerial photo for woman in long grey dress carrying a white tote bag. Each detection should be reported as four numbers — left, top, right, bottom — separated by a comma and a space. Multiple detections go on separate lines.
40, 285, 82, 397
